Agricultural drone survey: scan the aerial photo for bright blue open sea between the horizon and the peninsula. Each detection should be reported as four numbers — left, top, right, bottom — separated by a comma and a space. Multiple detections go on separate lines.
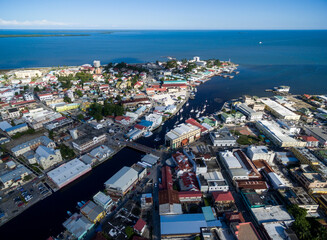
0, 30, 327, 69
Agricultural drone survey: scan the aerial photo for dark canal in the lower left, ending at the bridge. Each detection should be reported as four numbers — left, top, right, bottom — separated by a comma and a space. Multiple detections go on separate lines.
0, 148, 142, 240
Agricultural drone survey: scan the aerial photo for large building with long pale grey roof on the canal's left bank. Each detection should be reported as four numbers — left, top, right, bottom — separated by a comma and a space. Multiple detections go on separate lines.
47, 158, 92, 188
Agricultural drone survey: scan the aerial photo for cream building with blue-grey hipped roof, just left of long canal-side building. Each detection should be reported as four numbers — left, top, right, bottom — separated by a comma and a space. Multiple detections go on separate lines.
35, 145, 62, 170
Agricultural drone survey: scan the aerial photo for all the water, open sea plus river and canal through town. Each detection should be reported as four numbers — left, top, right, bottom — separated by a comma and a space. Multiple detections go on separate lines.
0, 30, 327, 239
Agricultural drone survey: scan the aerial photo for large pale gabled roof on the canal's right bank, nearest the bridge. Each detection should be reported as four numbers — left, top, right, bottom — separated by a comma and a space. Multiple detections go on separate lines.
104, 167, 138, 191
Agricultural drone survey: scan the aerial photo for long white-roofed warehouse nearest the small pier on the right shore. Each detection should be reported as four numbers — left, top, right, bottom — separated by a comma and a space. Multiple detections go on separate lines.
261, 98, 301, 121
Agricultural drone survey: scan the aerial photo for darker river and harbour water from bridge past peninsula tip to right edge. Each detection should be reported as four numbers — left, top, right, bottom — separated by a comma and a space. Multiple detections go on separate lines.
137, 65, 327, 147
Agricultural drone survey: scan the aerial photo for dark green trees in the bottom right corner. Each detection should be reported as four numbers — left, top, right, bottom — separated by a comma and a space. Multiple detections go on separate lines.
287, 204, 327, 240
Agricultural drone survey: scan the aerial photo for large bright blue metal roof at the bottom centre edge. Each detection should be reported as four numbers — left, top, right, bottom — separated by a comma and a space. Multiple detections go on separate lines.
160, 213, 207, 235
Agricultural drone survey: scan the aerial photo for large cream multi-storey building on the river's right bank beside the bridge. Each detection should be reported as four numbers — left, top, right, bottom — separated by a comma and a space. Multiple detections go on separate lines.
165, 124, 201, 148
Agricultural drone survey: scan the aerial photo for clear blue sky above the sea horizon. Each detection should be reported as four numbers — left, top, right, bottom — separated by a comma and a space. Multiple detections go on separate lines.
0, 0, 327, 29
